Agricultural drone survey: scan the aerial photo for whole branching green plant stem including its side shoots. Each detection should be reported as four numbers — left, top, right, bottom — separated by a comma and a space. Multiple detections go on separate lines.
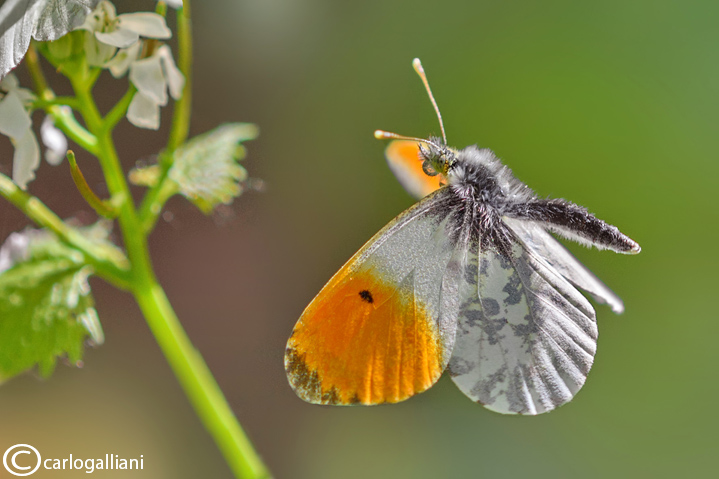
21, 0, 269, 479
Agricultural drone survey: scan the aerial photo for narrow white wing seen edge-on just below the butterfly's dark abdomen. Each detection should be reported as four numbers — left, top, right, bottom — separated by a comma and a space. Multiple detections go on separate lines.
503, 218, 624, 314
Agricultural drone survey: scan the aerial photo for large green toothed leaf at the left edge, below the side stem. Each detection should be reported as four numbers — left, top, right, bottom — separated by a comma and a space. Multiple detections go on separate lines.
0, 223, 109, 381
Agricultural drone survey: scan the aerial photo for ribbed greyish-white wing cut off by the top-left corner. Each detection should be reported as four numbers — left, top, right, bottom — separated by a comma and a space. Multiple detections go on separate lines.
0, 0, 99, 78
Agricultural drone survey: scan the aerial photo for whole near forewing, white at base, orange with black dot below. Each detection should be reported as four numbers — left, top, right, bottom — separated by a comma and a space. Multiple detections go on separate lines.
285, 190, 461, 404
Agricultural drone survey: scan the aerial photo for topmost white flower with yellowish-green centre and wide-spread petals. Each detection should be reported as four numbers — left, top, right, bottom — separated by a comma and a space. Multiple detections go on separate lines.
77, 0, 172, 67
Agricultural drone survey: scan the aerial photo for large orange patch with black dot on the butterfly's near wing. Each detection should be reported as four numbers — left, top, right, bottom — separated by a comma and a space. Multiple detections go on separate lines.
285, 268, 443, 404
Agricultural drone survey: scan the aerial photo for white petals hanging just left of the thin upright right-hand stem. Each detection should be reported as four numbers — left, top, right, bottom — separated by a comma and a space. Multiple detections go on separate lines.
127, 45, 185, 130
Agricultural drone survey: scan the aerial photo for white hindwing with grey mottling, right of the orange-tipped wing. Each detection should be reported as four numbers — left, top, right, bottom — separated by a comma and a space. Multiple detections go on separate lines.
449, 221, 597, 414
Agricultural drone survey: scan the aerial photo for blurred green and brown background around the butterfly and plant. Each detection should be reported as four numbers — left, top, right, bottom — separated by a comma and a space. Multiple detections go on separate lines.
0, 0, 719, 479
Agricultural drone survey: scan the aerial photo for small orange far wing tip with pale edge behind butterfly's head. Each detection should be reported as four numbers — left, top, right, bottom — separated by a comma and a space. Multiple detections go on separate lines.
385, 140, 442, 198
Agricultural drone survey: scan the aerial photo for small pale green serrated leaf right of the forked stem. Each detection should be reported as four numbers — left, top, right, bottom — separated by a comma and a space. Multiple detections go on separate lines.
169, 123, 258, 214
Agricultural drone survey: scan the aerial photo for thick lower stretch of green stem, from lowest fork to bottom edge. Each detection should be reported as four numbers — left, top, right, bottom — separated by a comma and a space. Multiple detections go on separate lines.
135, 281, 270, 479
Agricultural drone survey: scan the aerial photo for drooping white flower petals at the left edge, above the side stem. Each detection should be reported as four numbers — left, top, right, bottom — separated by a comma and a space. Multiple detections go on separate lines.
0, 74, 40, 189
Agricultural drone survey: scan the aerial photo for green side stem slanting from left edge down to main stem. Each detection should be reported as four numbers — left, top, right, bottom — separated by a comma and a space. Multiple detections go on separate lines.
0, 173, 131, 290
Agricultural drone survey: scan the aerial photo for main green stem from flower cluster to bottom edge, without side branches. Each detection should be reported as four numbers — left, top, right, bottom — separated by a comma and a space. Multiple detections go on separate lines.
70, 12, 269, 479
